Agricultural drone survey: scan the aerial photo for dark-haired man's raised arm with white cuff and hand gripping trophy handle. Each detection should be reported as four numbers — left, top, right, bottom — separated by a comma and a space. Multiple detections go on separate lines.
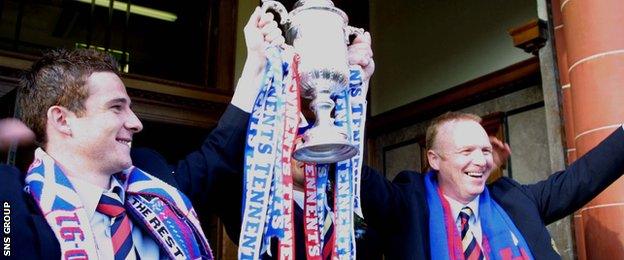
166, 8, 284, 241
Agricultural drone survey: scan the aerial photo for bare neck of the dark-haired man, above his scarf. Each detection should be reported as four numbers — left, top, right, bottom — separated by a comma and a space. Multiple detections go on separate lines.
46, 146, 111, 189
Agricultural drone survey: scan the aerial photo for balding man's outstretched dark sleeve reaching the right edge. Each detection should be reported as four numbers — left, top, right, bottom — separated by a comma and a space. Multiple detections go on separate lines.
525, 127, 624, 224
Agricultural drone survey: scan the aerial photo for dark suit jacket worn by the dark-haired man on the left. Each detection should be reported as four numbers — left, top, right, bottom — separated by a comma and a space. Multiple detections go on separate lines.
0, 105, 249, 259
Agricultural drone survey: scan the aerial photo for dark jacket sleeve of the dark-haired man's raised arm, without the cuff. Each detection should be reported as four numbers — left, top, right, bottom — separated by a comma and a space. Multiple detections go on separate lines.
174, 105, 249, 241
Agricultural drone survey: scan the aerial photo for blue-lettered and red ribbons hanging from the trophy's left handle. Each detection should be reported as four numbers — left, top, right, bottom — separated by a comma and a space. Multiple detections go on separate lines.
238, 47, 300, 259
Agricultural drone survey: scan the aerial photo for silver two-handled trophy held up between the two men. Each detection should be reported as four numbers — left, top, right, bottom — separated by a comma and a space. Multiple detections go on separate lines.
262, 0, 364, 163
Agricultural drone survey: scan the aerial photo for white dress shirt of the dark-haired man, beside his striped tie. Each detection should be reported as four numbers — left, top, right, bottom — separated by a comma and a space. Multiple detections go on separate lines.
68, 176, 166, 260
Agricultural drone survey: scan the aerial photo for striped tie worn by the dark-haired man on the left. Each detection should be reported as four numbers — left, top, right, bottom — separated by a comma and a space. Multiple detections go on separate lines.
96, 192, 134, 260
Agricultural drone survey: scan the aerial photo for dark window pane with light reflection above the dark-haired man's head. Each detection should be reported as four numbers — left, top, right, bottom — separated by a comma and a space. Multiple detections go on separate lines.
0, 0, 219, 86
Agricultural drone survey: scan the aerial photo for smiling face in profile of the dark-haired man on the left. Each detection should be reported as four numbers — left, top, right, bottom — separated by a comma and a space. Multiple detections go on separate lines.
68, 72, 143, 174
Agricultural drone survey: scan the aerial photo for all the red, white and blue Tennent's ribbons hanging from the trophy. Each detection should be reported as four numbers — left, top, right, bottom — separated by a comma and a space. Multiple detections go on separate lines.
238, 46, 366, 259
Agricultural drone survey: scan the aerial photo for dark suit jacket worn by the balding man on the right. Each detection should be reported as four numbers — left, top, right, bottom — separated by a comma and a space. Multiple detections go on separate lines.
362, 127, 624, 259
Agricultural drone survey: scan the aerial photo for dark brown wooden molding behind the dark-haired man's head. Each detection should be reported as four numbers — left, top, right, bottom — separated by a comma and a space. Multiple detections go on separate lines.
0, 51, 231, 128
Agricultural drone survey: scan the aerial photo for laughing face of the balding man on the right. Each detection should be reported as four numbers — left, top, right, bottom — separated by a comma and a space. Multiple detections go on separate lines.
428, 120, 493, 204
